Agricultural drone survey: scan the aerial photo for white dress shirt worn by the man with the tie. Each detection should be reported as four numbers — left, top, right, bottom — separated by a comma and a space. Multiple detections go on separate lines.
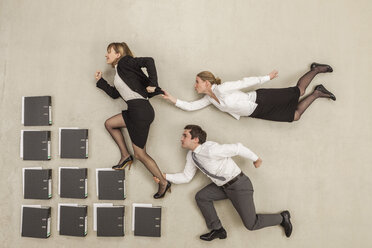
166, 141, 258, 186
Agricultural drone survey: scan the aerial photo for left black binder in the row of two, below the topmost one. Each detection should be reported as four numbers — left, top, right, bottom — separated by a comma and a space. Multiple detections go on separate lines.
20, 130, 51, 160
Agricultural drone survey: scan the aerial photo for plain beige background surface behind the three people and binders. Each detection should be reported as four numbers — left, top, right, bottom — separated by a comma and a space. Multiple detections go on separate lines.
0, 0, 372, 248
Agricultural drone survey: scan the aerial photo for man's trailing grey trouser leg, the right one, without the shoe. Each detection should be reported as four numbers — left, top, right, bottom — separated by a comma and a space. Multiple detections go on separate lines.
225, 175, 283, 230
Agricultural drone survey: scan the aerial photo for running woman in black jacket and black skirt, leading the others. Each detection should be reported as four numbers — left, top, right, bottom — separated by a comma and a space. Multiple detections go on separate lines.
95, 42, 171, 198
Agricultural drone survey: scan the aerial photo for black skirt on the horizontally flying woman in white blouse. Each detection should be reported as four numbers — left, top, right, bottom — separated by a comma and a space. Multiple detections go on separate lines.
250, 86, 300, 122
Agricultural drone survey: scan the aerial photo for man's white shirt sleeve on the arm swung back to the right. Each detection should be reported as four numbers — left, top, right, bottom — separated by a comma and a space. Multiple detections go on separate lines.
209, 143, 258, 161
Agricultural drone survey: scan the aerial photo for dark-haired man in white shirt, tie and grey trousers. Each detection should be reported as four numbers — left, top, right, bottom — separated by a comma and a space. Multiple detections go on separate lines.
155, 125, 292, 241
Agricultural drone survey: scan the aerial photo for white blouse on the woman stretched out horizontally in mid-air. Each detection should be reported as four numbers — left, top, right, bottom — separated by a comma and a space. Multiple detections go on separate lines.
176, 76, 270, 120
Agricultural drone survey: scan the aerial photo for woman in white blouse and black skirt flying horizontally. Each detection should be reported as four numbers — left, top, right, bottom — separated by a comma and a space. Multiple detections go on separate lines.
163, 63, 336, 122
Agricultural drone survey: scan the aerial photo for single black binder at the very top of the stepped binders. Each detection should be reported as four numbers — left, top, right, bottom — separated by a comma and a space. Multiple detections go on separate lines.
22, 96, 52, 126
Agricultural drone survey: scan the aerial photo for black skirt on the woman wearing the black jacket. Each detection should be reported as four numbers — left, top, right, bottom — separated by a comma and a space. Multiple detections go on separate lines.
121, 99, 155, 149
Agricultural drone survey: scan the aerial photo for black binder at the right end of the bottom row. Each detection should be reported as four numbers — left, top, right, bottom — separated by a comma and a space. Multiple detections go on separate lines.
132, 203, 161, 237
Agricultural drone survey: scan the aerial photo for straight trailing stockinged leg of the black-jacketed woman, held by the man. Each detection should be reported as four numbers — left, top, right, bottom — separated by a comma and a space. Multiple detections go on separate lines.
132, 144, 167, 193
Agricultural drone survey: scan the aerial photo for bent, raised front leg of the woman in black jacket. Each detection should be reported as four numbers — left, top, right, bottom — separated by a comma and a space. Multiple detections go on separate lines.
105, 114, 129, 164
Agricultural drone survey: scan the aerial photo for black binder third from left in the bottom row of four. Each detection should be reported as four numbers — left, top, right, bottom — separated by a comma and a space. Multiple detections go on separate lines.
93, 203, 125, 237
